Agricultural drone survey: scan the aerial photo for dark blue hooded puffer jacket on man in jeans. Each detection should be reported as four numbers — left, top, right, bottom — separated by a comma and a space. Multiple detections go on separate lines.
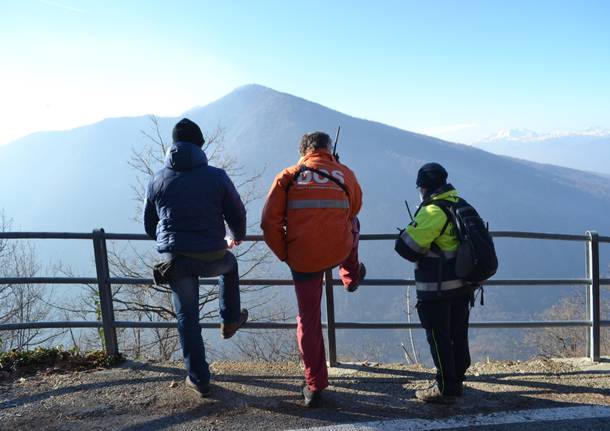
144, 142, 246, 253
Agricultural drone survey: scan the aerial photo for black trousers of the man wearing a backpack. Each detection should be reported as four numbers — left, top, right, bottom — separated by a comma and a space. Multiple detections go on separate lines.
417, 294, 472, 395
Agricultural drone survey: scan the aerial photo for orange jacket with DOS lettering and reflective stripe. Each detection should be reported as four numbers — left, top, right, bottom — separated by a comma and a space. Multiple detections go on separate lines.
261, 150, 362, 272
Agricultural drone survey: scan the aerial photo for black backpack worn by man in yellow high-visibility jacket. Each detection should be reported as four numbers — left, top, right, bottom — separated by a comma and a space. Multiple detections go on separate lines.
424, 198, 498, 285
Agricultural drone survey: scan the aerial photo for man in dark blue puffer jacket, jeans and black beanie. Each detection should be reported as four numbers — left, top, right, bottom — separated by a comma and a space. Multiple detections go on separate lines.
144, 118, 248, 396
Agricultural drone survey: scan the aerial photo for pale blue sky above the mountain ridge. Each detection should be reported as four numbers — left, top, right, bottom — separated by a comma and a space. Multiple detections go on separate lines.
0, 0, 610, 144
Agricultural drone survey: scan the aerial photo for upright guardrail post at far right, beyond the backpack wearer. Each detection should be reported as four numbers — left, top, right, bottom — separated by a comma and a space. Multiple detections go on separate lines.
587, 231, 601, 362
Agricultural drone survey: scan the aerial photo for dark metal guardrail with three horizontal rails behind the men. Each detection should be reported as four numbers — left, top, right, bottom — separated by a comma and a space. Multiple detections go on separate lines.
0, 229, 610, 366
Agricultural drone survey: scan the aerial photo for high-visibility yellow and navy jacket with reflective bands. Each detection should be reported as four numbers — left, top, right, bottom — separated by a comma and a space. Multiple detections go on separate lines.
400, 184, 470, 299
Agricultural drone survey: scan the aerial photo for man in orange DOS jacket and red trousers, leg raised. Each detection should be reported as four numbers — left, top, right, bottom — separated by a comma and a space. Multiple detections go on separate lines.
261, 132, 366, 407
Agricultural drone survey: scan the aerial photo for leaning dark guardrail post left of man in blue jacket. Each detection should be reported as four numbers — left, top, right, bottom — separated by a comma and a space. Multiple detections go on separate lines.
93, 229, 119, 358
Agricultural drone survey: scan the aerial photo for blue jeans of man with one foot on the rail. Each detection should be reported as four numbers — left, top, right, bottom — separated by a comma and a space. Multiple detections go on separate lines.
168, 251, 241, 385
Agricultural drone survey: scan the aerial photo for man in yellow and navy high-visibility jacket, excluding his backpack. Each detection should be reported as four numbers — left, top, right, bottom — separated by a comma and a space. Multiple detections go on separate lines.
396, 163, 472, 404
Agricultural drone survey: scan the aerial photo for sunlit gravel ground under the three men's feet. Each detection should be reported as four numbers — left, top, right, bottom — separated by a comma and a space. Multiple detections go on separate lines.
0, 360, 610, 431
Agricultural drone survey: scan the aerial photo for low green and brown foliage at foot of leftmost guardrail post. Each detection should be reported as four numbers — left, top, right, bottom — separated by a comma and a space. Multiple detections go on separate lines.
0, 346, 123, 372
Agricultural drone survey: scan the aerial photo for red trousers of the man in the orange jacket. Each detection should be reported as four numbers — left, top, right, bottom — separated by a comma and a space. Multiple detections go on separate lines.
292, 219, 360, 391
